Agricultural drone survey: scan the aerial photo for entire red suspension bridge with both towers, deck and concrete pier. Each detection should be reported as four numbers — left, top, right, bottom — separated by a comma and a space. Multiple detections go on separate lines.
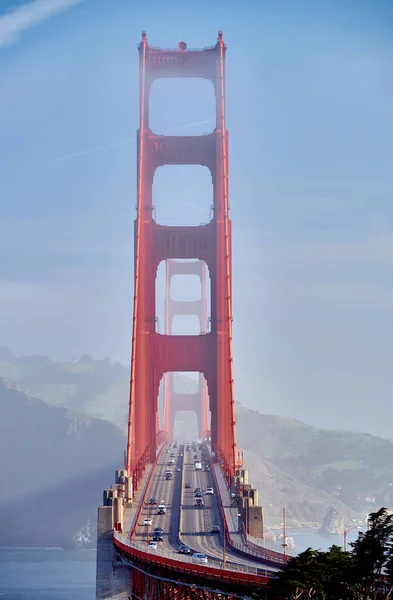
97, 32, 287, 600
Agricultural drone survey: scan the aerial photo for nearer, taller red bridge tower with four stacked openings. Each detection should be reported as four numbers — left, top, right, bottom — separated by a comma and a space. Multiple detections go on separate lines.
127, 32, 237, 488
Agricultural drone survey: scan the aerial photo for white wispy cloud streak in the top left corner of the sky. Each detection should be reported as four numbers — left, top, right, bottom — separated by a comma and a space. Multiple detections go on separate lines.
0, 0, 82, 47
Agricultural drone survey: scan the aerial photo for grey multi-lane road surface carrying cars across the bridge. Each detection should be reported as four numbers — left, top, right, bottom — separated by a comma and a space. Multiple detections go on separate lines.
130, 444, 278, 571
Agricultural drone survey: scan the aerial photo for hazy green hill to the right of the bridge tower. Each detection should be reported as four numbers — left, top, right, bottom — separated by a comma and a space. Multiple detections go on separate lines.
236, 405, 393, 518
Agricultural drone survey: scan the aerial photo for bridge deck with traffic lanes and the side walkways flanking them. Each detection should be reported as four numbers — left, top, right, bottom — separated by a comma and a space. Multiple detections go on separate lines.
115, 445, 278, 577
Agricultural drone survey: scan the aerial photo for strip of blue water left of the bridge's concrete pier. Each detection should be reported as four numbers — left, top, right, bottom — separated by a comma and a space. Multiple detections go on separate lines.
0, 548, 96, 600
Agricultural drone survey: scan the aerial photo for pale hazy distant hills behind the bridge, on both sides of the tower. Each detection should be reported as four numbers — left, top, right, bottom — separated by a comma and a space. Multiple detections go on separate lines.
0, 349, 393, 522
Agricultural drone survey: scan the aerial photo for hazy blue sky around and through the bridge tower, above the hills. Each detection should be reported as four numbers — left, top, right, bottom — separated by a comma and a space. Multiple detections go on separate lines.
0, 0, 393, 437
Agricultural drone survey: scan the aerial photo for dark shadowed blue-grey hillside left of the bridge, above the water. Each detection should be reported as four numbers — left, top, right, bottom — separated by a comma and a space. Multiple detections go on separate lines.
0, 378, 125, 546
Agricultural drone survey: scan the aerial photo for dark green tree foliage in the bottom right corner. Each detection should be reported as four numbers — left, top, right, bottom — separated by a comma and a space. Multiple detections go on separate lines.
269, 508, 393, 600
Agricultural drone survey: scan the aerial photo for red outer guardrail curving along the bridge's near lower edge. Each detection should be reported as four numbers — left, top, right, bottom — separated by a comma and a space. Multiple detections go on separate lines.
113, 535, 269, 587
